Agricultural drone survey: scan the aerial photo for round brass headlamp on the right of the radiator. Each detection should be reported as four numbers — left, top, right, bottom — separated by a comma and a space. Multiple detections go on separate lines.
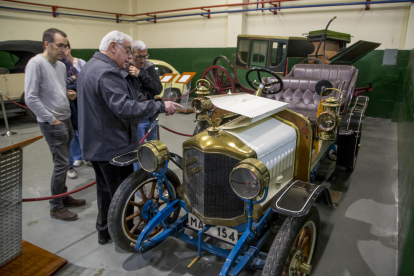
230, 158, 270, 199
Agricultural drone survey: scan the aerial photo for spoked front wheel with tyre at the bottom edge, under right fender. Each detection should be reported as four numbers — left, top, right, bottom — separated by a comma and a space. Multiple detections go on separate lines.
263, 207, 320, 276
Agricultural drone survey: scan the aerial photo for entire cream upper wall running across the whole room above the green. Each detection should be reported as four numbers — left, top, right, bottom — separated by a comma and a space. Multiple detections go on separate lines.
0, 0, 414, 49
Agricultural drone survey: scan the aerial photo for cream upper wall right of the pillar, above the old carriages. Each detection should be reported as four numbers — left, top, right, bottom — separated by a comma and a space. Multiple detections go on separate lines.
247, 1, 414, 49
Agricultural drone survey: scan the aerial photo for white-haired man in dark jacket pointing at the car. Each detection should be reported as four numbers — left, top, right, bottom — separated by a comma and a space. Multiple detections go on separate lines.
77, 31, 181, 244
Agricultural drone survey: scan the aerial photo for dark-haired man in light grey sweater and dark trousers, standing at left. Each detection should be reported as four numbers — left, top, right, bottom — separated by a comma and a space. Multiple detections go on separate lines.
25, 28, 85, 220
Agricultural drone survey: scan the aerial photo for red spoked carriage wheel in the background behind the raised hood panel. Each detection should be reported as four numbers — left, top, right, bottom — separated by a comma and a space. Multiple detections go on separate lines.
202, 65, 236, 95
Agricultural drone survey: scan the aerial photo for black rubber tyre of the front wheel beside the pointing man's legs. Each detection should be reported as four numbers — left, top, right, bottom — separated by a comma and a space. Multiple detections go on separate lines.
108, 169, 181, 253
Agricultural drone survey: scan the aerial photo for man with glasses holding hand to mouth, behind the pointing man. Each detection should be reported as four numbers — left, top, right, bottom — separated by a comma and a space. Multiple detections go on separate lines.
129, 40, 162, 170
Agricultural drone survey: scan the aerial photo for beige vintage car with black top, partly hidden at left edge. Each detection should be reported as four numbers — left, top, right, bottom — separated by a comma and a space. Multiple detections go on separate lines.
0, 40, 43, 117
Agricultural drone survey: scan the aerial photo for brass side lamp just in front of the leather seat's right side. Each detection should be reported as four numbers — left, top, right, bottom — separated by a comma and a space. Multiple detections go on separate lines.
315, 80, 344, 140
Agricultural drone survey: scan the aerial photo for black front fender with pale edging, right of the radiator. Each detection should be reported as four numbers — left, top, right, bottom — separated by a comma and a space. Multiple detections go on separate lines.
271, 180, 334, 217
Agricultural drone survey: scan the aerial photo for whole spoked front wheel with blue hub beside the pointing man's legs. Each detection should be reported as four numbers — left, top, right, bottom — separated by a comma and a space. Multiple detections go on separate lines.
108, 169, 180, 252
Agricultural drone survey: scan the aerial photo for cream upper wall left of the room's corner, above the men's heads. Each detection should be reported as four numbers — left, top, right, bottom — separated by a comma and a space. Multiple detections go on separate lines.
0, 0, 132, 49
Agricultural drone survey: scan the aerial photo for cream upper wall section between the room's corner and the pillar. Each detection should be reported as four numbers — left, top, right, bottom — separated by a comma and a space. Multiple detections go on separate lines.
133, 0, 228, 48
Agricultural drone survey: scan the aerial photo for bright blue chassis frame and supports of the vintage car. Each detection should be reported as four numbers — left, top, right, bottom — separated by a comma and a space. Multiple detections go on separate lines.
134, 143, 336, 276
